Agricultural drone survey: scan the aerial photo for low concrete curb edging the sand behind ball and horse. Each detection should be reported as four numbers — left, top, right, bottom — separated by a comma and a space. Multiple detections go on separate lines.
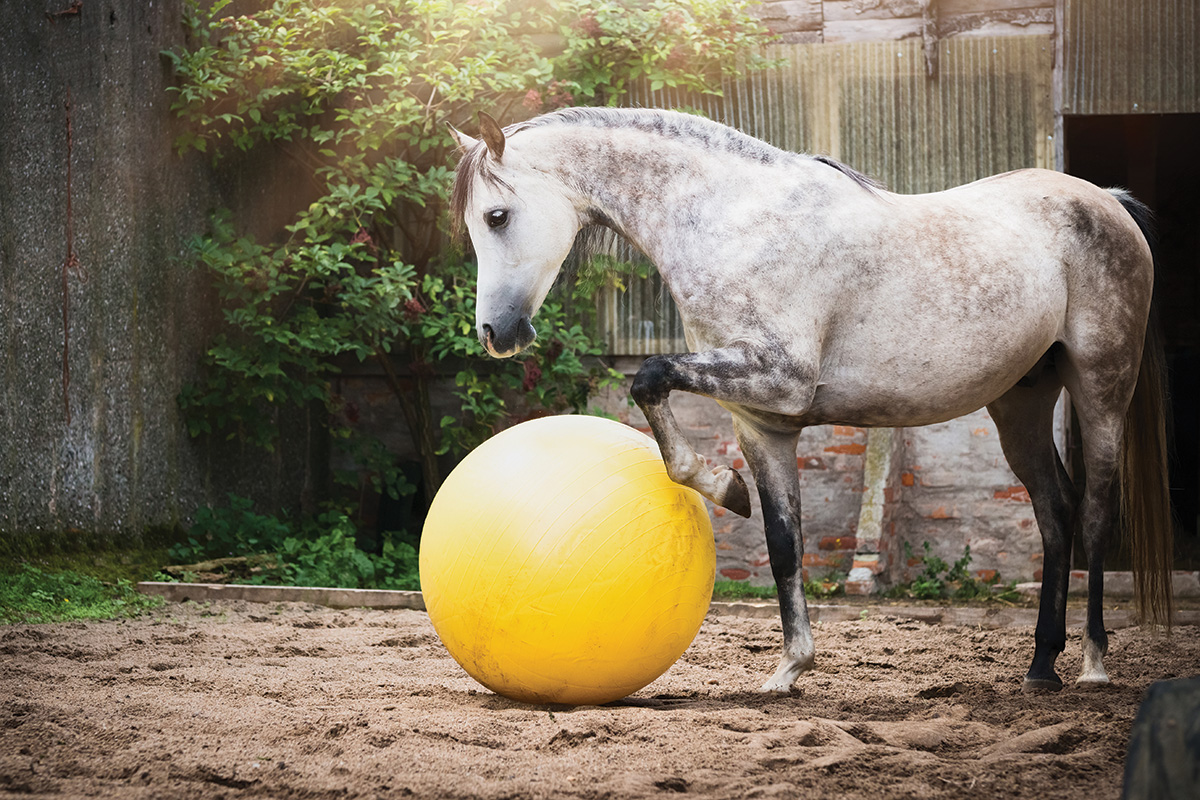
137, 581, 1200, 628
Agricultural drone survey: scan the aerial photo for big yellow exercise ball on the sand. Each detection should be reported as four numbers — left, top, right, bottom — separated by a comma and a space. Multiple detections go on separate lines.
420, 415, 716, 705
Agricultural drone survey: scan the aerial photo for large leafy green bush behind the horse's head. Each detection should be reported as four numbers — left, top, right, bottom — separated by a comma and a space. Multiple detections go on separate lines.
164, 0, 768, 520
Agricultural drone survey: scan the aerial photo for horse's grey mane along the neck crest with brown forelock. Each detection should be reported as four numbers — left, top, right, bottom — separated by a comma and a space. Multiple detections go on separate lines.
450, 107, 883, 234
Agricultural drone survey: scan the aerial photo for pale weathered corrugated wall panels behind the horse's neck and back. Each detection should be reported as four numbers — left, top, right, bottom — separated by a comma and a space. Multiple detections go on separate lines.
600, 36, 1054, 355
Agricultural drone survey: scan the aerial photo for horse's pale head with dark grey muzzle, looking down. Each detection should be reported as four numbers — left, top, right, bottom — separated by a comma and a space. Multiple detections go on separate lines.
450, 114, 581, 359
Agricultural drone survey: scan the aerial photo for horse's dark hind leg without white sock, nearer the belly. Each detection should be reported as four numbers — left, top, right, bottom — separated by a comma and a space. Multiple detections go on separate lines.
988, 351, 1076, 691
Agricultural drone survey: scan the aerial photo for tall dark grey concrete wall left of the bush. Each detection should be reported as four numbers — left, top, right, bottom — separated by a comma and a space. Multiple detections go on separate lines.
0, 0, 302, 552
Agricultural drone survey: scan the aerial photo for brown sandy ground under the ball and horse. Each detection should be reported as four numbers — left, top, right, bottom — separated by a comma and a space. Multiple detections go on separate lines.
0, 602, 1200, 800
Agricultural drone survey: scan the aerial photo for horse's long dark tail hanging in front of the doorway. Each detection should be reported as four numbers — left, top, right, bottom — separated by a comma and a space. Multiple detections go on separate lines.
1112, 190, 1175, 630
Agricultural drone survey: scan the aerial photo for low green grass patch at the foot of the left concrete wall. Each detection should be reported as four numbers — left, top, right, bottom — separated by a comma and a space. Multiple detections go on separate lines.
0, 564, 163, 624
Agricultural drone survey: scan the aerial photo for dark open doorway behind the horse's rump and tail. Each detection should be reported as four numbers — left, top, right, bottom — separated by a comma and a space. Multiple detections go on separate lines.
1064, 114, 1200, 570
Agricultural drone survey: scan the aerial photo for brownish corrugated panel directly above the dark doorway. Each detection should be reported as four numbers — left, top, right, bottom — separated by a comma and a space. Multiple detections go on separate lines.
1062, 0, 1200, 114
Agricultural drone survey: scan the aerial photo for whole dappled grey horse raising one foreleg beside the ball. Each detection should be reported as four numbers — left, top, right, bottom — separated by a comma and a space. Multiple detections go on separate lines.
451, 108, 1171, 691
